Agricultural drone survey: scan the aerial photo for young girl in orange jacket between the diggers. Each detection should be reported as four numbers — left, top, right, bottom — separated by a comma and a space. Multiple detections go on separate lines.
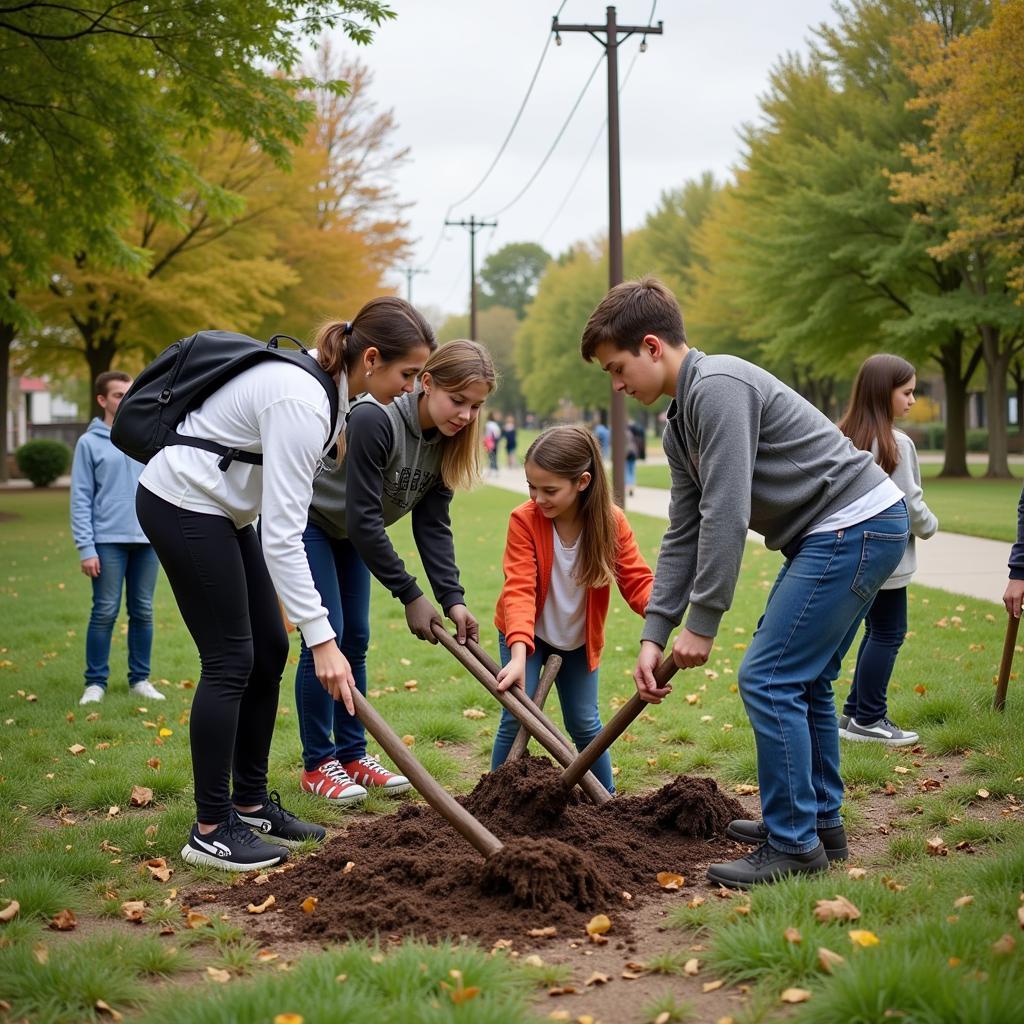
490, 427, 654, 793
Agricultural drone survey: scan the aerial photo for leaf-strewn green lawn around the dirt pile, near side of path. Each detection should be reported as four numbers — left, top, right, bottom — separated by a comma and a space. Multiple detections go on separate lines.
0, 488, 1024, 1024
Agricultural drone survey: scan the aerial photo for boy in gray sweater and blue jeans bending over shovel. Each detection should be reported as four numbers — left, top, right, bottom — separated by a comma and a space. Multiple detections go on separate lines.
581, 278, 908, 889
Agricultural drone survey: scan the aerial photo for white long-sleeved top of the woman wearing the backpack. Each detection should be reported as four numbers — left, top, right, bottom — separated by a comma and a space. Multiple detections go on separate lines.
139, 360, 348, 646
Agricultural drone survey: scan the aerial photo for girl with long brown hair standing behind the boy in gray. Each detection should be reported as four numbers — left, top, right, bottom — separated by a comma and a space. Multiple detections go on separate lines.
839, 354, 939, 746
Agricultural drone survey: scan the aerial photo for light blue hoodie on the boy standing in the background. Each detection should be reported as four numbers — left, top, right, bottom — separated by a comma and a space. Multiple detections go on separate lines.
71, 419, 150, 561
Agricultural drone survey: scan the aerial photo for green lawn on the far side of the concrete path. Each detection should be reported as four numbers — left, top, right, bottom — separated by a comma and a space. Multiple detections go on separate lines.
637, 463, 1024, 544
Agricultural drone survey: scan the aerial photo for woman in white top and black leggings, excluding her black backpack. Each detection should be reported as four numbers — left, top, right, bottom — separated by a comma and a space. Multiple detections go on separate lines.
136, 297, 436, 870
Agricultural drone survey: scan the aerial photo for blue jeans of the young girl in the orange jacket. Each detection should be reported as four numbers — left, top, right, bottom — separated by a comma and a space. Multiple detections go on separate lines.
490, 633, 615, 793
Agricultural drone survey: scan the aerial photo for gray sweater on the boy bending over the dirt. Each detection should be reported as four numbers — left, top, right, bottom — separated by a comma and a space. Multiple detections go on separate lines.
642, 349, 886, 647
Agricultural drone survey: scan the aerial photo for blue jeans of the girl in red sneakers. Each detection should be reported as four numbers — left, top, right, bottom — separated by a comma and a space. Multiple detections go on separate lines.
295, 523, 370, 771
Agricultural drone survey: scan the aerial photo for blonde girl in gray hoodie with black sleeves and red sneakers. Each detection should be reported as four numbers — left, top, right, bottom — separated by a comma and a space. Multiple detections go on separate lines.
295, 341, 496, 804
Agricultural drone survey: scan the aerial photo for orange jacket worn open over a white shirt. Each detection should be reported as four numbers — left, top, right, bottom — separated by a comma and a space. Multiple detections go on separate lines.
495, 501, 654, 672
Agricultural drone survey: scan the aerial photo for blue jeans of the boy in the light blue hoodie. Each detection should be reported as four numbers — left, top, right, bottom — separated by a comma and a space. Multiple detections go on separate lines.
85, 544, 160, 689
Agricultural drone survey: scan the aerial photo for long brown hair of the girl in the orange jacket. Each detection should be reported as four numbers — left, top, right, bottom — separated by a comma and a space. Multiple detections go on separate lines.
523, 427, 618, 588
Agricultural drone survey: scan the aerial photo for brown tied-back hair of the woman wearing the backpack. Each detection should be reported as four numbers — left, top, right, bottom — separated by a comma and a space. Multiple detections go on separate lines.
315, 295, 437, 377
